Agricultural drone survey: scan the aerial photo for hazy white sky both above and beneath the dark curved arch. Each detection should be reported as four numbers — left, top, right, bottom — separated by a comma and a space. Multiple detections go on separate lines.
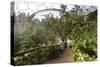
15, 1, 73, 18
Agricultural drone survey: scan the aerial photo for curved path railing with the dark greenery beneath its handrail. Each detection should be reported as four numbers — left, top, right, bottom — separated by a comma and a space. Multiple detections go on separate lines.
13, 45, 60, 65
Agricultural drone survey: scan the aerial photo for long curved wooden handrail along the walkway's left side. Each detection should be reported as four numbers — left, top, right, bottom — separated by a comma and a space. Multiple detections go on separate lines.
14, 45, 60, 57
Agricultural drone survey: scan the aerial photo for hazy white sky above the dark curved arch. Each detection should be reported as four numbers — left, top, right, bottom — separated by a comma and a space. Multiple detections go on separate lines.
15, 1, 73, 14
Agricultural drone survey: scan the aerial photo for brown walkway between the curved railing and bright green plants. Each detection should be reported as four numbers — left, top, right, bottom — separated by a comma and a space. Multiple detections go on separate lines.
46, 48, 74, 64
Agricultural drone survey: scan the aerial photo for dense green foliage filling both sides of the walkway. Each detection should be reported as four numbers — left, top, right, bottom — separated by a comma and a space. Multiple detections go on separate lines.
14, 5, 97, 65
